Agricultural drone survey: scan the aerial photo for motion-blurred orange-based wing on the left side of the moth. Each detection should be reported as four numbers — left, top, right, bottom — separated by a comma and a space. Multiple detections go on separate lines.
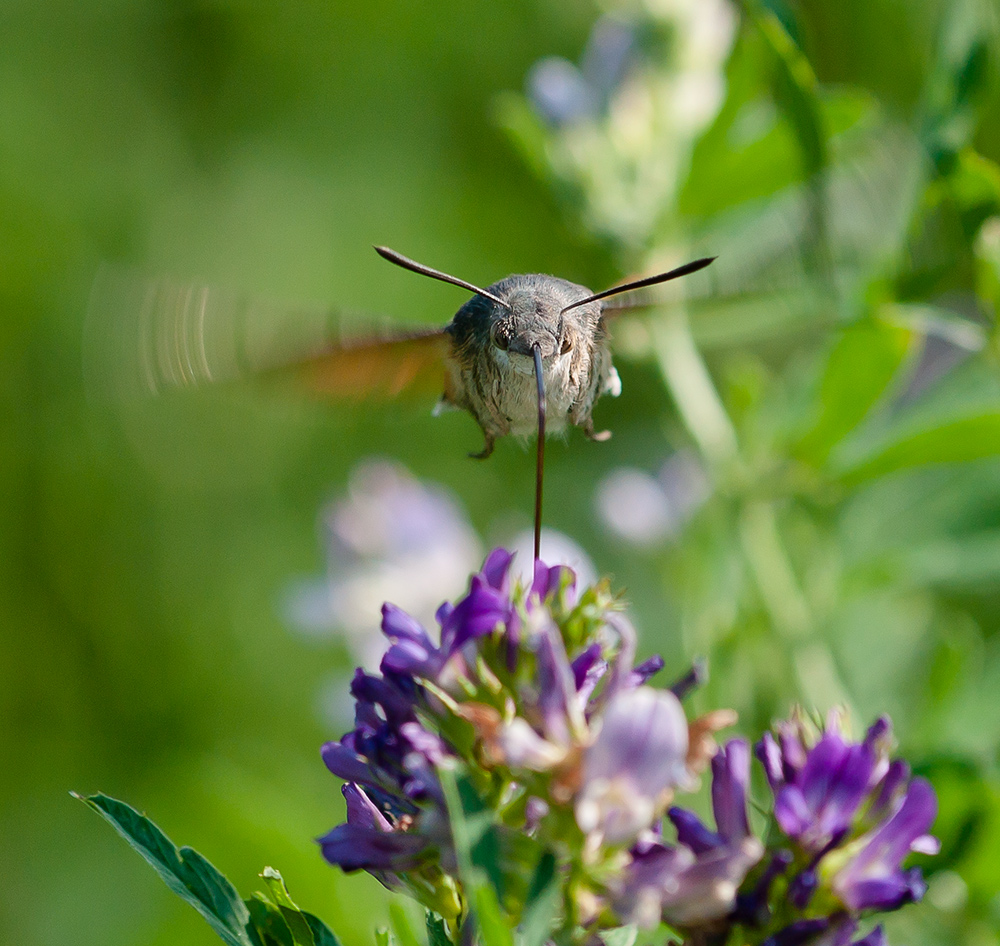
84, 266, 448, 401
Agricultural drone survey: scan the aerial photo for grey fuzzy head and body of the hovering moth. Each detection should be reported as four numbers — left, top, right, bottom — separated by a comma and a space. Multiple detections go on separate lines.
443, 274, 620, 455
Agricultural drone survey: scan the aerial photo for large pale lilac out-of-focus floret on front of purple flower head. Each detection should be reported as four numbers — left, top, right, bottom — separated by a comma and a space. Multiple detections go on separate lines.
575, 687, 688, 846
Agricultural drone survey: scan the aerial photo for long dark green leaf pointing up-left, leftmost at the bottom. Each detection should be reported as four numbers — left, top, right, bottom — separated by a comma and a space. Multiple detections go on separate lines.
74, 794, 258, 946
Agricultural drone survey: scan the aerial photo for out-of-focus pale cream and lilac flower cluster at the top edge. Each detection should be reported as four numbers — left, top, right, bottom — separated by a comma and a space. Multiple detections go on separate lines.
505, 0, 737, 249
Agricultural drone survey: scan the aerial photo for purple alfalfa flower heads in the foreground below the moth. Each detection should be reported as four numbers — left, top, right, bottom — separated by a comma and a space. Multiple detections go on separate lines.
320, 549, 934, 946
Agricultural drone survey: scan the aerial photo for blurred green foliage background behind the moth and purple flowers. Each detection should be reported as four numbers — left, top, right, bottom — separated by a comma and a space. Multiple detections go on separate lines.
0, 0, 1000, 946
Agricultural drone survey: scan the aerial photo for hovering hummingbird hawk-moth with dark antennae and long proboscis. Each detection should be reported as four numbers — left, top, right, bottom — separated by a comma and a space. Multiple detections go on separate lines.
84, 246, 714, 557
